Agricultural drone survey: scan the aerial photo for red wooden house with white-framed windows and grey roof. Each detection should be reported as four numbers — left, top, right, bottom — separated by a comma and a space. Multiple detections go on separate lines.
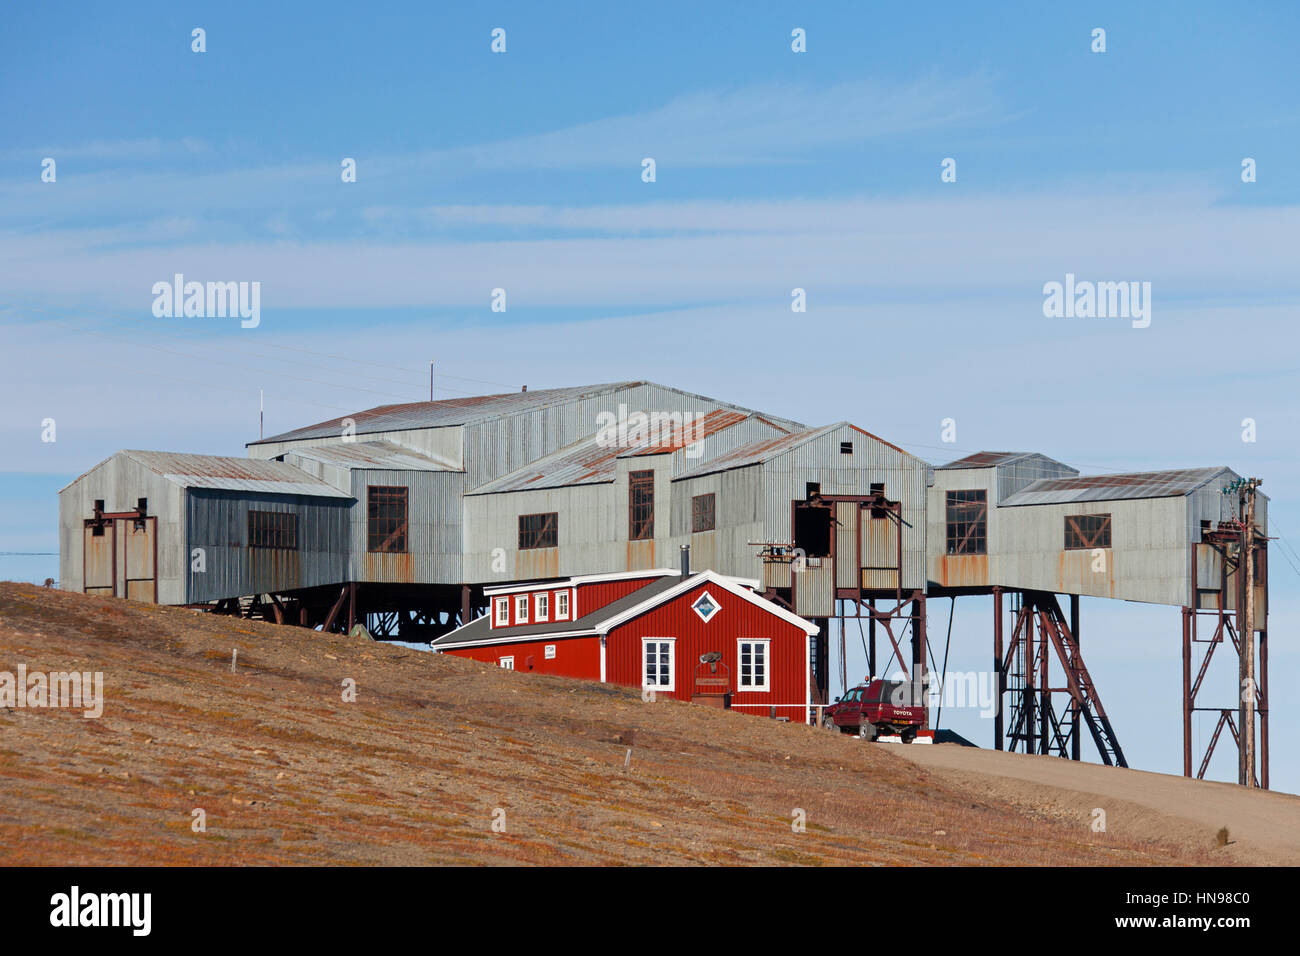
432, 570, 816, 722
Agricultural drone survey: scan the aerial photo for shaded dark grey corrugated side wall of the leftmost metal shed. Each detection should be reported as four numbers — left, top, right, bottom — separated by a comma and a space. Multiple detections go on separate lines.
185, 489, 351, 602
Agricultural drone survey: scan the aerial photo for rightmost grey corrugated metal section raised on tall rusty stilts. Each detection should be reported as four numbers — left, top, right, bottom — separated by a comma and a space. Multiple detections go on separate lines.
930, 451, 1268, 607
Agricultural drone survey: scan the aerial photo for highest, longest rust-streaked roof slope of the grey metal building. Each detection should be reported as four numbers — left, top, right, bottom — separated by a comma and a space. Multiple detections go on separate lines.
248, 381, 646, 446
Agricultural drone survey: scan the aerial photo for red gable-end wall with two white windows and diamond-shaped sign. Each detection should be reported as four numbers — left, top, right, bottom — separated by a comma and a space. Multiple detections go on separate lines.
606, 581, 809, 723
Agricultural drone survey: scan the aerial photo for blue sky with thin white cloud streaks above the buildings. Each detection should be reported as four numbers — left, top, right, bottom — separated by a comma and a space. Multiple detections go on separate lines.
0, 3, 1300, 791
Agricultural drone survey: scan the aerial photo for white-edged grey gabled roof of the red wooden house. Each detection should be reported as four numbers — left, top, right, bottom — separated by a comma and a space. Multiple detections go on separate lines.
430, 571, 818, 650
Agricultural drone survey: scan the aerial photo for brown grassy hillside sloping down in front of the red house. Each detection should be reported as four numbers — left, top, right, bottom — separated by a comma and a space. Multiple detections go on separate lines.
0, 583, 1274, 866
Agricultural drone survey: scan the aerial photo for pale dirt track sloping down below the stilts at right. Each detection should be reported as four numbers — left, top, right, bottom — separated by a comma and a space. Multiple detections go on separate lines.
878, 744, 1300, 866
